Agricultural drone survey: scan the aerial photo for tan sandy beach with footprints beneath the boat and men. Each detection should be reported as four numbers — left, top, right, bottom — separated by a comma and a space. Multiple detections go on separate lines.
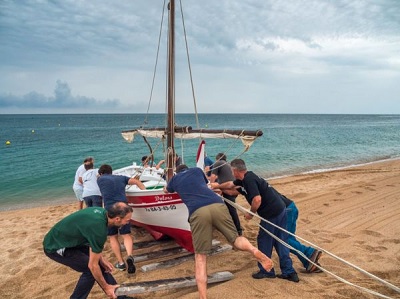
0, 160, 400, 299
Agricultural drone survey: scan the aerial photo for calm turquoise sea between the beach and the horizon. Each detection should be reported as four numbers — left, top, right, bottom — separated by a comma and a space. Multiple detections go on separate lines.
0, 114, 400, 210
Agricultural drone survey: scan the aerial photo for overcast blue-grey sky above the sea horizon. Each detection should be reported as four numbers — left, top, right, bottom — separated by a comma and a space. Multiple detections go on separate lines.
0, 0, 400, 114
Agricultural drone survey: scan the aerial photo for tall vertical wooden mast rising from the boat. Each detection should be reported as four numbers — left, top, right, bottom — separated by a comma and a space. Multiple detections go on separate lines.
167, 0, 175, 181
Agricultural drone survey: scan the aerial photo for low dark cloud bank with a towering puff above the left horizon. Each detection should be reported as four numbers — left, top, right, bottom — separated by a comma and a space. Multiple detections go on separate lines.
0, 80, 120, 109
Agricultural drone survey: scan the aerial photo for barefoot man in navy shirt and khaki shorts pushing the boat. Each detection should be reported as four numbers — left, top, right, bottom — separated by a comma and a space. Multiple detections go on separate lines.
165, 164, 273, 298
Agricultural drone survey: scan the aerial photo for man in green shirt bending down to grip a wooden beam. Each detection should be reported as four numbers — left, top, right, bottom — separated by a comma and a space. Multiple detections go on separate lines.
43, 202, 132, 299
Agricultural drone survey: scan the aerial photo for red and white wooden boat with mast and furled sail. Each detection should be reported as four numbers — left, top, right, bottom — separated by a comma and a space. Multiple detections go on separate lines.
114, 0, 263, 252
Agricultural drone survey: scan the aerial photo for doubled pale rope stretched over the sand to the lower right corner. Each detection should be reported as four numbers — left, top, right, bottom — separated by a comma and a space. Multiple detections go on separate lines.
221, 196, 400, 299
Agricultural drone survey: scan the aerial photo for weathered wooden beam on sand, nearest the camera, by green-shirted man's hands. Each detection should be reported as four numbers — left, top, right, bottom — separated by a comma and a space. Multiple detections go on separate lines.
115, 271, 233, 296
